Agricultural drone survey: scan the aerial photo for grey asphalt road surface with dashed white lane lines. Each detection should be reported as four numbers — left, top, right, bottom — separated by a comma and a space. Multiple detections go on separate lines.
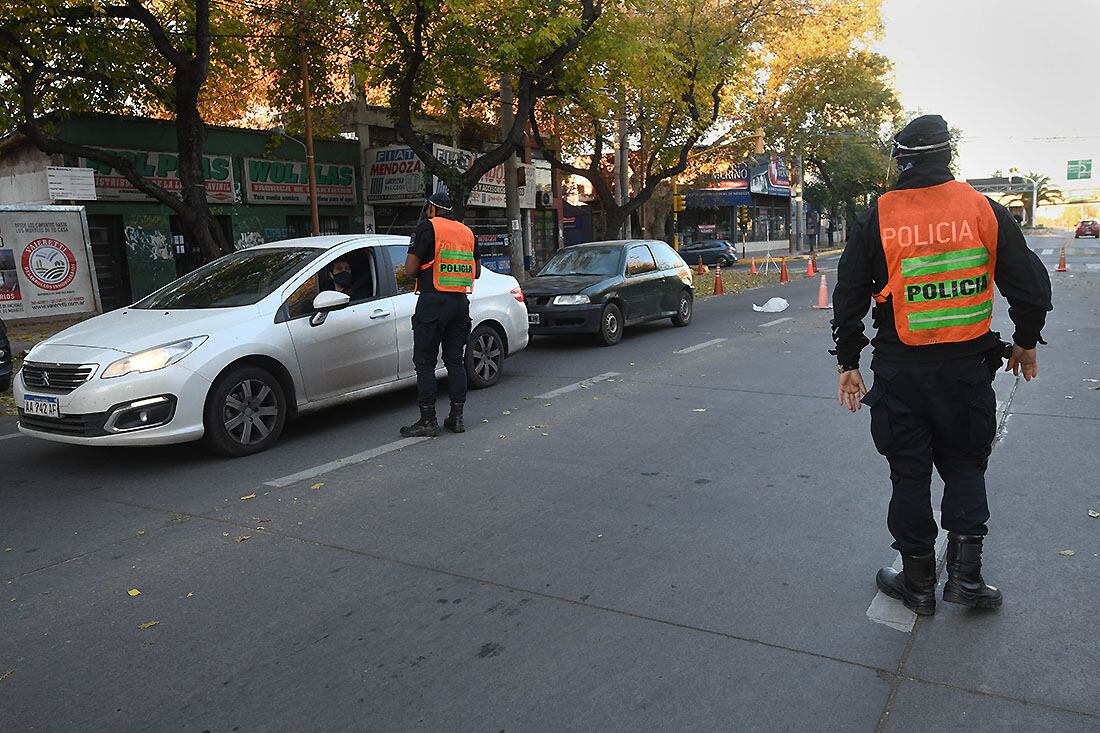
0, 238, 1100, 731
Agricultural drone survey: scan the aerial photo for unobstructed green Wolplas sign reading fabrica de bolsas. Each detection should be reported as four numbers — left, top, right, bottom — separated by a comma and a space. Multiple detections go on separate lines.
244, 157, 355, 206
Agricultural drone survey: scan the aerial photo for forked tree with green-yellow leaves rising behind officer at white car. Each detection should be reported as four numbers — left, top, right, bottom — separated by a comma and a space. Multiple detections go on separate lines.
349, 0, 604, 217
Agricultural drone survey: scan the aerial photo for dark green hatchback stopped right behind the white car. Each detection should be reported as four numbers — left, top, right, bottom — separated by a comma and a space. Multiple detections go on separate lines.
524, 240, 695, 346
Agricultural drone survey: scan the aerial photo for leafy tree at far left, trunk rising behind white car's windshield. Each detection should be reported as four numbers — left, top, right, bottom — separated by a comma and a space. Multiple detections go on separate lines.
0, 0, 265, 256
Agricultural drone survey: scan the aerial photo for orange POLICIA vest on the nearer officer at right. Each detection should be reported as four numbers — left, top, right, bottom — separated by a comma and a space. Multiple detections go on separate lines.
875, 180, 998, 346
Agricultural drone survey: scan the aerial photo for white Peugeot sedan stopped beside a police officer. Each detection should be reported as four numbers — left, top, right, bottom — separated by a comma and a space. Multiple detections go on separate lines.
14, 234, 528, 456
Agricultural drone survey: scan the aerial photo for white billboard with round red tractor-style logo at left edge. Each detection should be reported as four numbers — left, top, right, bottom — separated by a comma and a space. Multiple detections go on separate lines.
0, 206, 97, 320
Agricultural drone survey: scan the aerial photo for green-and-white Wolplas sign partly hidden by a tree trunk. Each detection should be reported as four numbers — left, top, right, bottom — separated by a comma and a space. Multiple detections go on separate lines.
79, 150, 234, 204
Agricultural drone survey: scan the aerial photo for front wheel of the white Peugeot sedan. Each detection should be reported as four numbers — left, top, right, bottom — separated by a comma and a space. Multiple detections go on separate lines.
204, 365, 287, 457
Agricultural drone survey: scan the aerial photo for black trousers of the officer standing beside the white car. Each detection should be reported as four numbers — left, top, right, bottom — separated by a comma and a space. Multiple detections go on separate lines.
413, 293, 470, 405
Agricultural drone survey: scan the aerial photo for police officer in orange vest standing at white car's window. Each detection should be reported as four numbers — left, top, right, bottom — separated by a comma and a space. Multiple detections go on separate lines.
402, 190, 481, 438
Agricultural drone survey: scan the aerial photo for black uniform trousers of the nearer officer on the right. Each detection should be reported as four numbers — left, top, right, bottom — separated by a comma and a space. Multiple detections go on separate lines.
862, 354, 1000, 555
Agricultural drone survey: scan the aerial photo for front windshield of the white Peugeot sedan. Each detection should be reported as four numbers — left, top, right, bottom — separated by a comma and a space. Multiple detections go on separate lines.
134, 247, 325, 310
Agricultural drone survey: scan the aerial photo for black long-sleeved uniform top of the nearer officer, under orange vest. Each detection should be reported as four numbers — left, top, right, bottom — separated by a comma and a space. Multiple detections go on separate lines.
833, 165, 1052, 367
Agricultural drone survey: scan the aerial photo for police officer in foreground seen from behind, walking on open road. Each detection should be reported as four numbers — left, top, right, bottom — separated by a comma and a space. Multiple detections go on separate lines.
833, 114, 1051, 615
